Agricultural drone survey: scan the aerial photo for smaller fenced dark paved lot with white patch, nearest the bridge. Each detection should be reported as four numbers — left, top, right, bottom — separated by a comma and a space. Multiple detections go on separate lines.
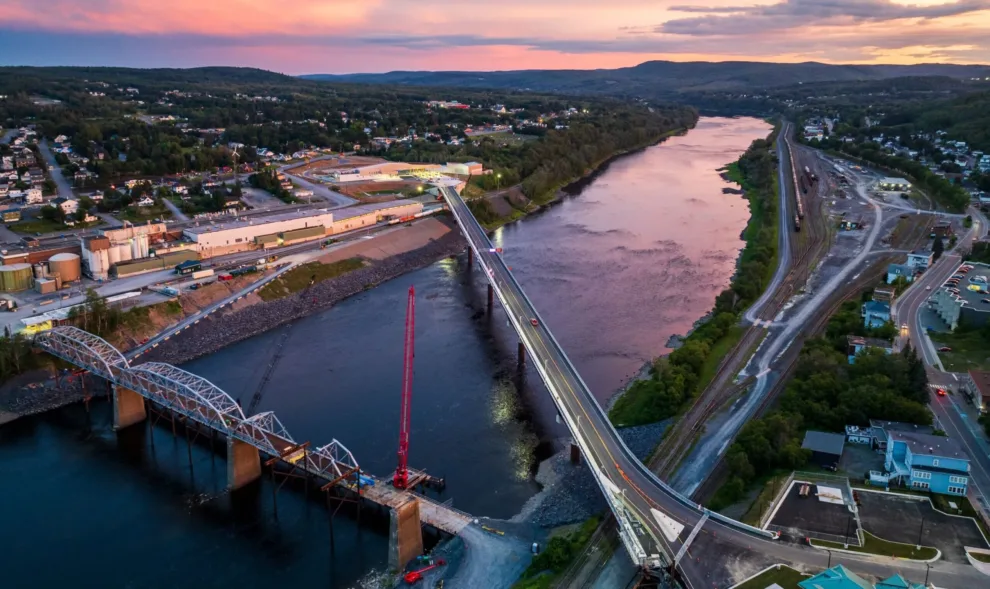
770, 481, 858, 543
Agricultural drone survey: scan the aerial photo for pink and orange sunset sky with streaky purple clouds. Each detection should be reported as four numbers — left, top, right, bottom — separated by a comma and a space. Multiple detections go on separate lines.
0, 0, 990, 74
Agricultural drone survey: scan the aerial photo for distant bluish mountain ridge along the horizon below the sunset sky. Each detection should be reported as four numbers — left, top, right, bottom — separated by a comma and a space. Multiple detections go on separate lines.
299, 61, 990, 95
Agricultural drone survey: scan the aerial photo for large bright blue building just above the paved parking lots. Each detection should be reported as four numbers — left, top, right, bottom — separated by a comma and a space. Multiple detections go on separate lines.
884, 431, 969, 496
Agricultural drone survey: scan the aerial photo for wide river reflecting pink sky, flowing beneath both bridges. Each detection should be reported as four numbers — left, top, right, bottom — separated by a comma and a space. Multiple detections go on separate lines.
0, 118, 770, 587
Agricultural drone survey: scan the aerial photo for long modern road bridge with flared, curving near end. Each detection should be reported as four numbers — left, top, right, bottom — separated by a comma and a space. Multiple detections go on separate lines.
440, 188, 780, 587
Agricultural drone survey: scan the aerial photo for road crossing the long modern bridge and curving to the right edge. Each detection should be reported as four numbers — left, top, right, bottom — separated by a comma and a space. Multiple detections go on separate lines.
441, 188, 986, 589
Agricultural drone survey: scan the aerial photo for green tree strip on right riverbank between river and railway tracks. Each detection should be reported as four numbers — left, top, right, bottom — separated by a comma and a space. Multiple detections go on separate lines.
609, 131, 778, 426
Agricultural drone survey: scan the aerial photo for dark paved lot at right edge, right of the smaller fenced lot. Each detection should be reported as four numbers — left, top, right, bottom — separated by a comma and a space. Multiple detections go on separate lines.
857, 491, 990, 564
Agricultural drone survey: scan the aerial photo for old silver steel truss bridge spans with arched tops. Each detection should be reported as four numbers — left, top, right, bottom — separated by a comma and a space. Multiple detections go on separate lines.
34, 326, 360, 484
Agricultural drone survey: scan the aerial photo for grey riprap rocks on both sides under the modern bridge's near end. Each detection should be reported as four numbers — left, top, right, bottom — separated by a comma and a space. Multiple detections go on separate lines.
512, 420, 670, 528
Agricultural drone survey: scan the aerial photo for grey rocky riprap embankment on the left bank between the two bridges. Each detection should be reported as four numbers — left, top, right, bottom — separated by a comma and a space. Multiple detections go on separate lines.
142, 231, 467, 364
